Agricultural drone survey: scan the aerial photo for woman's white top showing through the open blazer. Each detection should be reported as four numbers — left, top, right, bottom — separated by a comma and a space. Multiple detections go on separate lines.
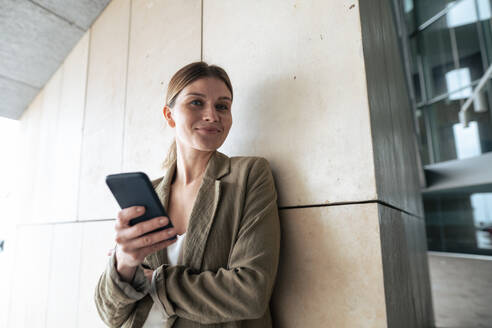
142, 233, 186, 328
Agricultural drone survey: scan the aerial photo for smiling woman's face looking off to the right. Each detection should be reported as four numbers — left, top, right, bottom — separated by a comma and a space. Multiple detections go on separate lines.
164, 77, 232, 151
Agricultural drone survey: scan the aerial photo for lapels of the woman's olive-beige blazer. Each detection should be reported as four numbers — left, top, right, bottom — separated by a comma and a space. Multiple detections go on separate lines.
156, 151, 230, 270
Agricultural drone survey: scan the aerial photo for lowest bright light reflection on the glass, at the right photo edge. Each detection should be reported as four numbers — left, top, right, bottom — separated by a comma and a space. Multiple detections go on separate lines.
470, 193, 492, 249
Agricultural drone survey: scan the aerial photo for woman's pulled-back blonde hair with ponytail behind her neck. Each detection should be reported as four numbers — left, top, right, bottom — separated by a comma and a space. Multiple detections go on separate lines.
162, 61, 233, 169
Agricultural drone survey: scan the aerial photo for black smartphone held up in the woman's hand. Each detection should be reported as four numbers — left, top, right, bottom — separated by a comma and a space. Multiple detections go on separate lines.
106, 172, 176, 239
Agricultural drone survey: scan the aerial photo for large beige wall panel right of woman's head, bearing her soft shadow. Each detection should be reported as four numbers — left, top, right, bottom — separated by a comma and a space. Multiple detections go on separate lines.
203, 0, 376, 206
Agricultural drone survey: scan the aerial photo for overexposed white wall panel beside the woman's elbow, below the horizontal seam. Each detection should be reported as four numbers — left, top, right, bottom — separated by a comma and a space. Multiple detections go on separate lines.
77, 221, 115, 328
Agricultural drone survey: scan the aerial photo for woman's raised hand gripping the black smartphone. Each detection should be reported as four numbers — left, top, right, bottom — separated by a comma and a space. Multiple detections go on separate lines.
115, 206, 176, 282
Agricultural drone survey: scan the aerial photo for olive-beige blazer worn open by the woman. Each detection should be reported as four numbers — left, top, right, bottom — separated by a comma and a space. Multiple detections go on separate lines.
95, 151, 280, 328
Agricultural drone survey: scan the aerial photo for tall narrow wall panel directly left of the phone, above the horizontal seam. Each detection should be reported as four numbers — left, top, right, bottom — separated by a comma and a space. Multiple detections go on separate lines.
78, 0, 130, 220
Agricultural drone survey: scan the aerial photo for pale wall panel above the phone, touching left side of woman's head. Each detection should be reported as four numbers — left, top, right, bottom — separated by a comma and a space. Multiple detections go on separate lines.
123, 0, 201, 178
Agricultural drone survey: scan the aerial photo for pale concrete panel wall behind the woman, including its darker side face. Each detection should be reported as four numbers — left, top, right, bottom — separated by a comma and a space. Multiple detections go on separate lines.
5, 0, 432, 327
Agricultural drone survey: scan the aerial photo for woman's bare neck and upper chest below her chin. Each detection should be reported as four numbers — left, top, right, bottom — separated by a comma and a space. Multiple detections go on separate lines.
173, 142, 214, 186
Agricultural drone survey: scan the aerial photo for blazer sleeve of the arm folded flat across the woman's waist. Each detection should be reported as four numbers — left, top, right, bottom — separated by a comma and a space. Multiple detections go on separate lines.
155, 158, 280, 324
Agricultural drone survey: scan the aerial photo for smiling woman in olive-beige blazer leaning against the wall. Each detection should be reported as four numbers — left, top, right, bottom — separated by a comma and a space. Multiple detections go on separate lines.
95, 62, 280, 328
